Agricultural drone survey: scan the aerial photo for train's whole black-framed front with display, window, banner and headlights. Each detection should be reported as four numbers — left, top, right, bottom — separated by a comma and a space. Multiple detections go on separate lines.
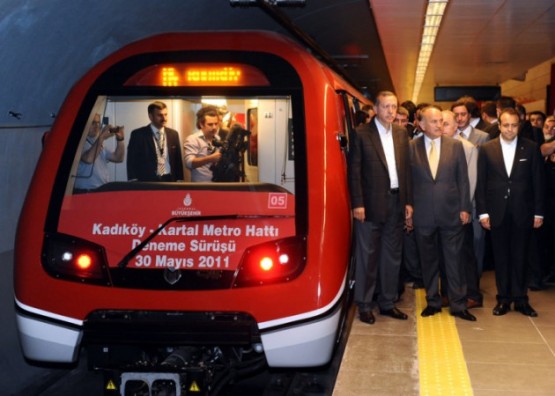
44, 55, 307, 288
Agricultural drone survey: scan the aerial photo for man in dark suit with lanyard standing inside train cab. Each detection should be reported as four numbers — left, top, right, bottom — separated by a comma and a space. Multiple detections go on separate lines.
127, 101, 183, 181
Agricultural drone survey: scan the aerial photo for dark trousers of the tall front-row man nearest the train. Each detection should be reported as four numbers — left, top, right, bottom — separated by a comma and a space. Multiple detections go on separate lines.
354, 195, 404, 311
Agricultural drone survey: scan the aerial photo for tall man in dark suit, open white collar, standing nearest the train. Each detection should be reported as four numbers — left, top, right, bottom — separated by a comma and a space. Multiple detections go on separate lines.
349, 91, 412, 324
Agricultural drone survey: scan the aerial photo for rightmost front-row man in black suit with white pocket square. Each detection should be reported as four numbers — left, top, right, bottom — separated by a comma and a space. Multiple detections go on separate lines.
476, 108, 544, 316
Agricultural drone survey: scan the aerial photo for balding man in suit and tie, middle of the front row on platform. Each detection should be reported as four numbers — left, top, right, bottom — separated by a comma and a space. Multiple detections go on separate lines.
410, 106, 476, 321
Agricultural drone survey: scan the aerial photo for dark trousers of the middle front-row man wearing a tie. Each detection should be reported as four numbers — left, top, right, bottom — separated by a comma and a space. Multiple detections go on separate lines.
415, 226, 466, 312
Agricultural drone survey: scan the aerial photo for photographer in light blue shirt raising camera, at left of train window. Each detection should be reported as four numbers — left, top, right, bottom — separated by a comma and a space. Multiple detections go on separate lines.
74, 113, 125, 193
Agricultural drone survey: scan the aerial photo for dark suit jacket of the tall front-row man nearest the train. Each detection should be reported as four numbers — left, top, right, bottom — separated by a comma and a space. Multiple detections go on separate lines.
348, 117, 412, 222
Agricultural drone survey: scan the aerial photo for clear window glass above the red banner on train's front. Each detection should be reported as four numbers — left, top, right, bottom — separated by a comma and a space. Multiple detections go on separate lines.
66, 96, 295, 195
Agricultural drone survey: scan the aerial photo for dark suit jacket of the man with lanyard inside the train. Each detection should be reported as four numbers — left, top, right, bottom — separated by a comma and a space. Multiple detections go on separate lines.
127, 125, 183, 181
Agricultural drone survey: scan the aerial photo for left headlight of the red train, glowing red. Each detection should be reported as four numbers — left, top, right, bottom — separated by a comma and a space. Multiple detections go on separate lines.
42, 234, 110, 284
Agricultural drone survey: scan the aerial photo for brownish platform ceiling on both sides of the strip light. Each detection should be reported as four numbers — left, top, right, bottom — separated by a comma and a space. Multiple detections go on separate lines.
369, 0, 555, 102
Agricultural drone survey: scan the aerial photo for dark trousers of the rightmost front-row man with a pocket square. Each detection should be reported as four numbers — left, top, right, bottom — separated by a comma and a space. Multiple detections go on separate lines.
491, 214, 532, 303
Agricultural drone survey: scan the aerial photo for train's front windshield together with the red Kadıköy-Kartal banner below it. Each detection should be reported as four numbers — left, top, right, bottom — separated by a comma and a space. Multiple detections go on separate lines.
50, 95, 303, 287
